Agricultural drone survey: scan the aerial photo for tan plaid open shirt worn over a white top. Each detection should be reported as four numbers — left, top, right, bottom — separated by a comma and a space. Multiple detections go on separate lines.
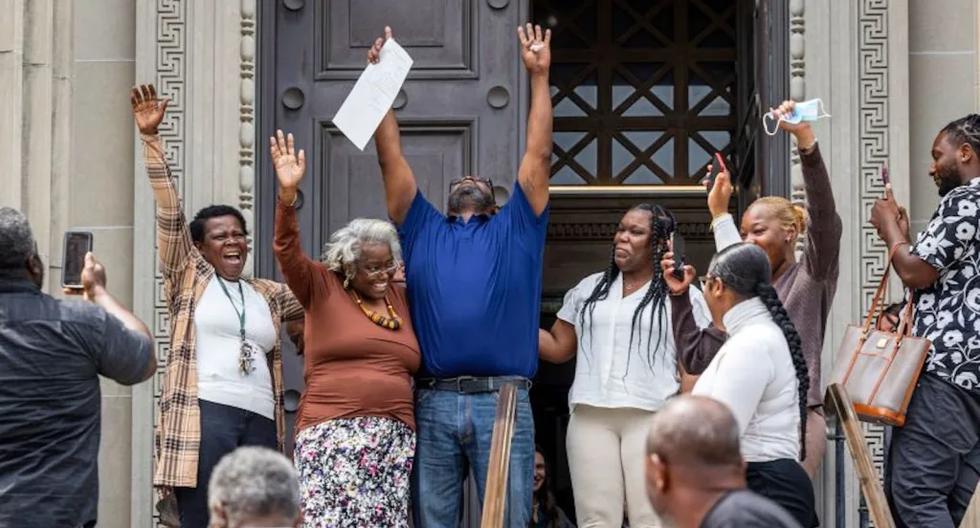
142, 135, 303, 490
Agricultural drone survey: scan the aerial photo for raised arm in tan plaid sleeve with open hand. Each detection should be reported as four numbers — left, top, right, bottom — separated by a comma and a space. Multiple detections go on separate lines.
130, 84, 193, 275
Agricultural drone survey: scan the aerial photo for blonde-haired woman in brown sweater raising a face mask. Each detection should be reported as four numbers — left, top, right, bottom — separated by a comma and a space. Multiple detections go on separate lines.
663, 101, 843, 477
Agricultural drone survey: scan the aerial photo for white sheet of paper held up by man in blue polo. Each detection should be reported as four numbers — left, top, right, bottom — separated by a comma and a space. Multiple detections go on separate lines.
333, 39, 412, 150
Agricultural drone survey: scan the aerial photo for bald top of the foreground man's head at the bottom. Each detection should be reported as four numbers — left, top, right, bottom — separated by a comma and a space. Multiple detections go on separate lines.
647, 395, 742, 467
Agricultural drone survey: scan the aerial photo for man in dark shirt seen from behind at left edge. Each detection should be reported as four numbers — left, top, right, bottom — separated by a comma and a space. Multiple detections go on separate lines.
0, 207, 157, 527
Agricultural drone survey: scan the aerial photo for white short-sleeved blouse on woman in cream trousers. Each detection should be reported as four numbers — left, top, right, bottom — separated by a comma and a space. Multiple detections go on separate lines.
558, 273, 711, 411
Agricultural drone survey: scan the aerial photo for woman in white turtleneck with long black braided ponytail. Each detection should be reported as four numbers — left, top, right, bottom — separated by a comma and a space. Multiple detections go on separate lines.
683, 242, 819, 527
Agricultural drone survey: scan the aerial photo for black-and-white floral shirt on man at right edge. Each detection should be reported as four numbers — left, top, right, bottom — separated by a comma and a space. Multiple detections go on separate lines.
912, 178, 980, 392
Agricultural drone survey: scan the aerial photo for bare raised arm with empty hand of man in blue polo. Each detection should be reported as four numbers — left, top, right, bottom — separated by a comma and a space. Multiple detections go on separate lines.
517, 24, 552, 215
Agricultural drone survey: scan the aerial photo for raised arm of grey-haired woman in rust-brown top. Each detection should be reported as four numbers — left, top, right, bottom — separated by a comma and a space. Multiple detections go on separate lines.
269, 130, 316, 307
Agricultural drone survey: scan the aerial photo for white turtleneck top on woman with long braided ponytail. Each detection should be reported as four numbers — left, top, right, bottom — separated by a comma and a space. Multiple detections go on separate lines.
692, 298, 800, 462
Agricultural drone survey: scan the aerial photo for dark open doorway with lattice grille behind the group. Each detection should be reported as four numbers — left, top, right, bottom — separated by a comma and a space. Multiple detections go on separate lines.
531, 0, 788, 515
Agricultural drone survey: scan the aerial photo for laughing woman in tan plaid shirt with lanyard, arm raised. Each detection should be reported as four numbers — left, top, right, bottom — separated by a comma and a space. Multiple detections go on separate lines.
131, 85, 303, 528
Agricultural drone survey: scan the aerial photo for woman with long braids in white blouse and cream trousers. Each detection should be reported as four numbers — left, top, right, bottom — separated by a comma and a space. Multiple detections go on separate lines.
539, 204, 710, 528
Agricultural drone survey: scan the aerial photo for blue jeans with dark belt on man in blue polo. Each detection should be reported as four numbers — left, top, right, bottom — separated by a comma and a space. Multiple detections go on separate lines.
412, 389, 534, 528
